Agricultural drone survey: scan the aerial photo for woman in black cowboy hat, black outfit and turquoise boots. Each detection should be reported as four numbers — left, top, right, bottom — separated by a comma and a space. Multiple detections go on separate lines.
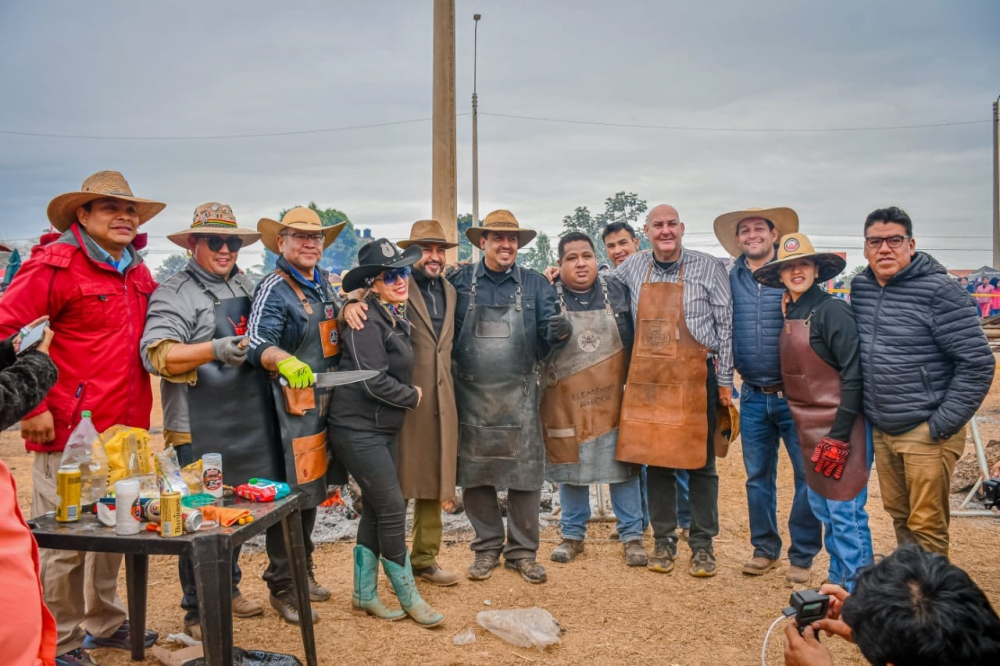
327, 238, 444, 627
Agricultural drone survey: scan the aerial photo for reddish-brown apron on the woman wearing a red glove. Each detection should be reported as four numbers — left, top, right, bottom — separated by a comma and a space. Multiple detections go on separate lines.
778, 315, 869, 501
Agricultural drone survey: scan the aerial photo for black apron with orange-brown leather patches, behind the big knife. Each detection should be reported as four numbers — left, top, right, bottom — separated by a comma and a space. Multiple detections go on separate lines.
271, 271, 347, 509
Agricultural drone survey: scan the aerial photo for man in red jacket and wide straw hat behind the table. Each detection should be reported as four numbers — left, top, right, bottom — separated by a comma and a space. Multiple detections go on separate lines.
0, 171, 164, 665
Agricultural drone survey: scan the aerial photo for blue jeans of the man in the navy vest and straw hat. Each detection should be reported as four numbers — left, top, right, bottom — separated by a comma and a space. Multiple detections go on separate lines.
740, 384, 823, 569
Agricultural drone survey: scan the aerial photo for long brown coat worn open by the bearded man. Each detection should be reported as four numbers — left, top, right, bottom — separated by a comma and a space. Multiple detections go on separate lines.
398, 278, 458, 500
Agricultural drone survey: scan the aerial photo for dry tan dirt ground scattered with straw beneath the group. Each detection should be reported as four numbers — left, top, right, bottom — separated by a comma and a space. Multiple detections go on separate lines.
0, 366, 1000, 665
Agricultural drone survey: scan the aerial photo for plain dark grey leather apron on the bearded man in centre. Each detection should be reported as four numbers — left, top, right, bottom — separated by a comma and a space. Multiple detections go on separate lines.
452, 280, 545, 490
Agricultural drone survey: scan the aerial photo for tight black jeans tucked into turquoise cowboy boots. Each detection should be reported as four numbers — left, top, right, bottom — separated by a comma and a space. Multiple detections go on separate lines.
331, 428, 406, 566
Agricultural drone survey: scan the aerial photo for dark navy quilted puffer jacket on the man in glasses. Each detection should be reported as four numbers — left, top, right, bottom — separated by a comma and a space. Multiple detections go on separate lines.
851, 252, 995, 439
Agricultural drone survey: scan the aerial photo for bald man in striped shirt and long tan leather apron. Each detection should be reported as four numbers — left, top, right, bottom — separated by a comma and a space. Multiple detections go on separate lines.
611, 204, 733, 577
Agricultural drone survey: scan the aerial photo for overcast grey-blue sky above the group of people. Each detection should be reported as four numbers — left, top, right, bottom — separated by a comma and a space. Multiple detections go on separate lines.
0, 0, 1000, 268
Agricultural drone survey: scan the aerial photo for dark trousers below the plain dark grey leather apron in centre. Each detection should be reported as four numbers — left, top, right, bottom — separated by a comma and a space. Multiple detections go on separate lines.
462, 486, 542, 560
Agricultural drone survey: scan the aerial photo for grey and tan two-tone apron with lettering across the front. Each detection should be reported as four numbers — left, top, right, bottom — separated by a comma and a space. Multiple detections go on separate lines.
541, 277, 634, 485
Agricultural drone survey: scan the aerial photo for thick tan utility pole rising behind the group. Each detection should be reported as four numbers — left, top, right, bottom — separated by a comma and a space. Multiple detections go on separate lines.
431, 0, 458, 262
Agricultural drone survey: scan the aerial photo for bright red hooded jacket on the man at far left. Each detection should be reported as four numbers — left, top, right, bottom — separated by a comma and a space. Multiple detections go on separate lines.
0, 224, 156, 452
